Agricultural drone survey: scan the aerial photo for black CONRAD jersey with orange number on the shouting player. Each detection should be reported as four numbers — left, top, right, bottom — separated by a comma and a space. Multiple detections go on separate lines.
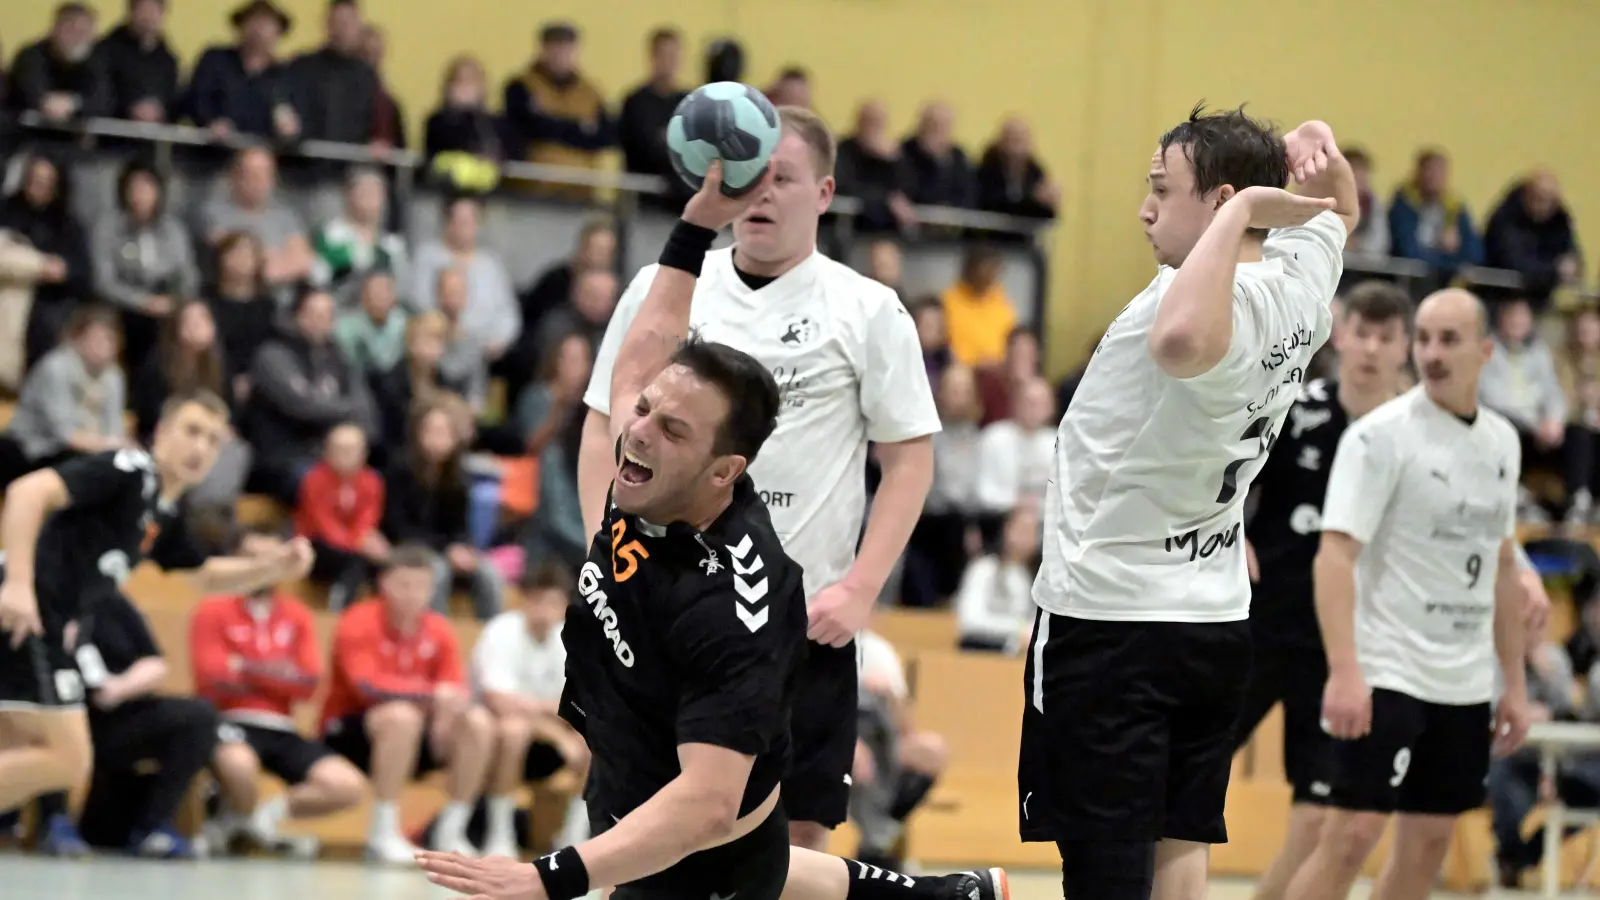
560, 476, 806, 822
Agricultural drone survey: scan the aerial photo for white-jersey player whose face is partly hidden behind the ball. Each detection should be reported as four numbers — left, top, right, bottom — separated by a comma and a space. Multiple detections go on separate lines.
578, 107, 939, 850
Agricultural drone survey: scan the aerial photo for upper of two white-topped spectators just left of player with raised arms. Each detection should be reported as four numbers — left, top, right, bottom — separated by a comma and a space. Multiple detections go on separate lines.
978, 376, 1058, 517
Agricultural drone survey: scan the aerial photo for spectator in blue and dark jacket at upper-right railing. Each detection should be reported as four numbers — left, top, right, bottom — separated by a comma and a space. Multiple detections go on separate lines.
1389, 151, 1483, 279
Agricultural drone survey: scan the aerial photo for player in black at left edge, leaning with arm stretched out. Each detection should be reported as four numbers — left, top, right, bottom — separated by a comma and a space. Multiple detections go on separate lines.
0, 392, 312, 810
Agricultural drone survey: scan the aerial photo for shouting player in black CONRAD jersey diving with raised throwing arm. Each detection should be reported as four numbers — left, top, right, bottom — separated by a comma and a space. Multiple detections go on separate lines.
419, 160, 1006, 900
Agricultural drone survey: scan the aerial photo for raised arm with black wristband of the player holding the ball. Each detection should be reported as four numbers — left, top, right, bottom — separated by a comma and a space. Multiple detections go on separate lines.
610, 162, 771, 436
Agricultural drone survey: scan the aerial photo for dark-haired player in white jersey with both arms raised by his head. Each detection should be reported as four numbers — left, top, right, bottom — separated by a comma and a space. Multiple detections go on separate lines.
1018, 109, 1360, 900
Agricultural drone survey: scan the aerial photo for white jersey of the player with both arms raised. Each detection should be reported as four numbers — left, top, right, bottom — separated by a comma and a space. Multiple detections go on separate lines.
1034, 211, 1346, 623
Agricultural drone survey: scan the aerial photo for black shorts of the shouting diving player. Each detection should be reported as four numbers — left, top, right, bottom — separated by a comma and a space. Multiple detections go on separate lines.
608, 804, 789, 900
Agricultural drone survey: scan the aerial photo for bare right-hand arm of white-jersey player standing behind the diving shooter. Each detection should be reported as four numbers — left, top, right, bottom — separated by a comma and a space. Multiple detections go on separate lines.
806, 436, 933, 647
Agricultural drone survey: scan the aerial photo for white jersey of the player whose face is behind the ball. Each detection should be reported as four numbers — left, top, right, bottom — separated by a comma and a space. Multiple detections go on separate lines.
584, 248, 939, 597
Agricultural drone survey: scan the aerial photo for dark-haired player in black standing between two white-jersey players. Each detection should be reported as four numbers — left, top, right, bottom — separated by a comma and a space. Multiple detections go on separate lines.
1237, 282, 1411, 900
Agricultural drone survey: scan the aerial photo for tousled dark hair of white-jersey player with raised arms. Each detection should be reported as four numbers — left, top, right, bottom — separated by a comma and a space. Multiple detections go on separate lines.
1162, 102, 1290, 197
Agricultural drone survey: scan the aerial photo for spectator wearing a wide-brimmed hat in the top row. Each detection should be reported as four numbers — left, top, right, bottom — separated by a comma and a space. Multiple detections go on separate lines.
189, 0, 301, 139
